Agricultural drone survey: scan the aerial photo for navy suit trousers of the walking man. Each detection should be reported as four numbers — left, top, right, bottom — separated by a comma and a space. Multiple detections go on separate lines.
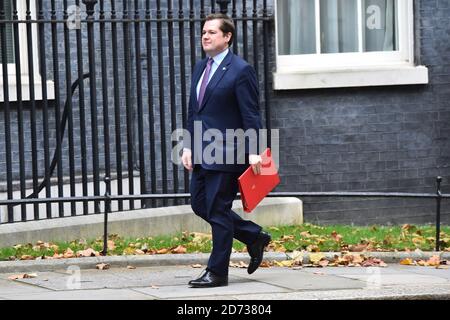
190, 165, 262, 276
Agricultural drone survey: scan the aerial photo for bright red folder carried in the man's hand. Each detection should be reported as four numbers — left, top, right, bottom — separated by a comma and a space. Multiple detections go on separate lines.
238, 148, 280, 213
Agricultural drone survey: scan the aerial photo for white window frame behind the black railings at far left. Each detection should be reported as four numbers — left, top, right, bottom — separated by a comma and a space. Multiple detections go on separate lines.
0, 0, 55, 102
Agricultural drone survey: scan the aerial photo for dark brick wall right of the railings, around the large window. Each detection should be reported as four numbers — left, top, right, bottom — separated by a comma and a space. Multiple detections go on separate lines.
271, 1, 450, 224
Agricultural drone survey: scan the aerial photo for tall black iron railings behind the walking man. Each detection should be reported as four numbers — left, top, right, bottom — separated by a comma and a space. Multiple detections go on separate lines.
0, 0, 273, 223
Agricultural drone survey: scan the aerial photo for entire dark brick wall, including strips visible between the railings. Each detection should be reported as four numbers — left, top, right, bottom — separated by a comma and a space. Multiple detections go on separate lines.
0, 0, 450, 224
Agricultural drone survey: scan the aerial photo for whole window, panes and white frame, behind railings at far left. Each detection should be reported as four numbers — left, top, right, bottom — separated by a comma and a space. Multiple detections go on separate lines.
0, 0, 55, 102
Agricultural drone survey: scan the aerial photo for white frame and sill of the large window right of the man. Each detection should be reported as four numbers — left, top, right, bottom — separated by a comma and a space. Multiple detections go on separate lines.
274, 0, 428, 90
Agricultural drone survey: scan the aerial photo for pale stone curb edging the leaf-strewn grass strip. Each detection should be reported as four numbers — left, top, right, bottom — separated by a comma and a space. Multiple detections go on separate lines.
0, 252, 450, 273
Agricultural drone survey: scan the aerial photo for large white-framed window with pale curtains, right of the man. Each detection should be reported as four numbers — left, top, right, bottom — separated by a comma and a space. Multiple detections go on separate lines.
274, 0, 428, 89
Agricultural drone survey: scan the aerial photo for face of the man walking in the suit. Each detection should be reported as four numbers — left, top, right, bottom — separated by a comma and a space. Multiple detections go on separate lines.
202, 19, 231, 57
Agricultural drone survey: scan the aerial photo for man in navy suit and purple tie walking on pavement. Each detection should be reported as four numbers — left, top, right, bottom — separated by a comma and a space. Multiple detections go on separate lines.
182, 14, 271, 288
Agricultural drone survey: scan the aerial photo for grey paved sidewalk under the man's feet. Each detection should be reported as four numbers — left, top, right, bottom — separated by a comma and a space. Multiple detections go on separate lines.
0, 264, 450, 300
